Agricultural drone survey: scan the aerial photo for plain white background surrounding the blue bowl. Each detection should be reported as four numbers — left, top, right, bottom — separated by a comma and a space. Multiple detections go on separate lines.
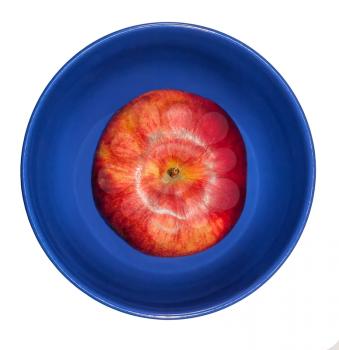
0, 0, 339, 350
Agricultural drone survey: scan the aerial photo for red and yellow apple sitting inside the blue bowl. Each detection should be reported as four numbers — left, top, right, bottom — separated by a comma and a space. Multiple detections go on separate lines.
92, 90, 247, 257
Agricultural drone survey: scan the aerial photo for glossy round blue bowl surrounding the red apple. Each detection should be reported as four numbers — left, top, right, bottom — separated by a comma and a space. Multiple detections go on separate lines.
21, 23, 315, 318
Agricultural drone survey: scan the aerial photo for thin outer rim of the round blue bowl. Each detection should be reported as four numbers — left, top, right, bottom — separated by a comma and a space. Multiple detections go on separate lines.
20, 22, 316, 319
